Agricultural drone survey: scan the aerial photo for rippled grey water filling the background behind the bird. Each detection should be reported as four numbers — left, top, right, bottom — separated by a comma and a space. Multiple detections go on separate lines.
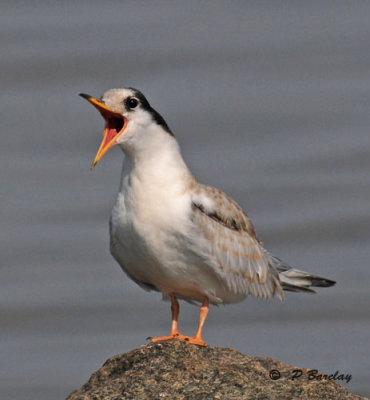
0, 1, 370, 400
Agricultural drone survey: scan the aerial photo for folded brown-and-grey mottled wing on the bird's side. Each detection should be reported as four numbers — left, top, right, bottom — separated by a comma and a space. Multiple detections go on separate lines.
192, 184, 282, 298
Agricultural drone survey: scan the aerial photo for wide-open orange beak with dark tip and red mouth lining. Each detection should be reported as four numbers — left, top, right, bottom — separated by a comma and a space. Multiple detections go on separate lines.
80, 93, 128, 170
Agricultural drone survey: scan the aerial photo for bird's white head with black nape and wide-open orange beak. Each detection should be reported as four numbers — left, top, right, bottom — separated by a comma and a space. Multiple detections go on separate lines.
80, 88, 174, 168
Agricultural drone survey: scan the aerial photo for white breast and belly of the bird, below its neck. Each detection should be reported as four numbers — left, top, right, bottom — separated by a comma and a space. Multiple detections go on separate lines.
110, 148, 220, 301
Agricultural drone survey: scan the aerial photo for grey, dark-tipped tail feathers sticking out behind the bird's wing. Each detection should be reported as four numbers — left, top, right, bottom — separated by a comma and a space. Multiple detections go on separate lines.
271, 256, 336, 293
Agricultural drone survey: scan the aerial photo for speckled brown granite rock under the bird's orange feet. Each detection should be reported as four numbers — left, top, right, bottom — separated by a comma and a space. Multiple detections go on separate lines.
67, 341, 365, 400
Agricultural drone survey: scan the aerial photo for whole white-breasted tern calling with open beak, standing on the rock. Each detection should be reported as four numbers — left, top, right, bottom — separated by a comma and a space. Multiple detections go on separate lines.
80, 87, 335, 346
